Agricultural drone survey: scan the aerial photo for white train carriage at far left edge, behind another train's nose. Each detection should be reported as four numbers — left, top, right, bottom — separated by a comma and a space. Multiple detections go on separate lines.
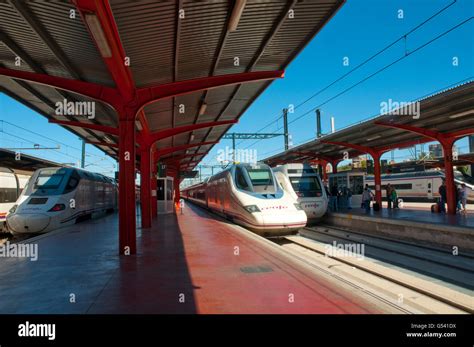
0, 167, 30, 230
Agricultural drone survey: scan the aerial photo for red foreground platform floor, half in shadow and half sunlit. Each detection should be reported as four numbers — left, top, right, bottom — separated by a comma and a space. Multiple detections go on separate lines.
0, 206, 381, 314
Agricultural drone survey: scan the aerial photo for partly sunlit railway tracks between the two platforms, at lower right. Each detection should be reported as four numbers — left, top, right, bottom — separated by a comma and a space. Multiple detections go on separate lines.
272, 226, 474, 313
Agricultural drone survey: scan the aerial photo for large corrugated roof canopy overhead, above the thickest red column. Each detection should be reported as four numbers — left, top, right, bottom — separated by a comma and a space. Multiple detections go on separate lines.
0, 0, 344, 169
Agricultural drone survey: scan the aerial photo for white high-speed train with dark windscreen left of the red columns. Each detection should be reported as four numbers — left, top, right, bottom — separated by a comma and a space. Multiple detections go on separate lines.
7, 167, 117, 234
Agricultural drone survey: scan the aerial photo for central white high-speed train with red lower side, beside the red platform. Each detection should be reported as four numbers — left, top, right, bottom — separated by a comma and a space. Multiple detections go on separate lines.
182, 164, 307, 236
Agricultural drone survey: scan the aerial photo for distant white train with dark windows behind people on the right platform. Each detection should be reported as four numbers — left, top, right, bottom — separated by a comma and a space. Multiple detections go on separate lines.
365, 170, 474, 203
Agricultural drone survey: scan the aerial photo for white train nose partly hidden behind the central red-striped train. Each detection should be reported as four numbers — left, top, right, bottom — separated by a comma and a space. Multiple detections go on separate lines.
273, 163, 328, 222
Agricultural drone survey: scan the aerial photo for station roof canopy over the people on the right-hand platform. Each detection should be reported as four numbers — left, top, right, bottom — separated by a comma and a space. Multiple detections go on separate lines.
263, 81, 474, 165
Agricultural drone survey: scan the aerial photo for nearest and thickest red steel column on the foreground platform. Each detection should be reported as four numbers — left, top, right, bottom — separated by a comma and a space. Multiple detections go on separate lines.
119, 114, 137, 255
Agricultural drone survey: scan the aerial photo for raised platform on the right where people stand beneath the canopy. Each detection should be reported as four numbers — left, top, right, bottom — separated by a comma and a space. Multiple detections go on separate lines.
325, 208, 474, 254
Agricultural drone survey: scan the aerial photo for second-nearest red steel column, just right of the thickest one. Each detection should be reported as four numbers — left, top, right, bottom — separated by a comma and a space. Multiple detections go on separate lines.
140, 144, 151, 228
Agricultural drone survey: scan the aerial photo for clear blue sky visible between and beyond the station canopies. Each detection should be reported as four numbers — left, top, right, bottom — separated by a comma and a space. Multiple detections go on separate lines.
0, 0, 474, 179
